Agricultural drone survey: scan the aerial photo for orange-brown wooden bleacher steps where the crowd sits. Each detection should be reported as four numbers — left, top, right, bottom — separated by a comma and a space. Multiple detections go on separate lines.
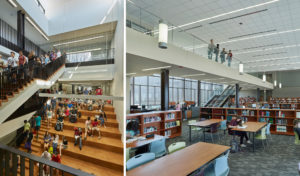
20, 105, 123, 176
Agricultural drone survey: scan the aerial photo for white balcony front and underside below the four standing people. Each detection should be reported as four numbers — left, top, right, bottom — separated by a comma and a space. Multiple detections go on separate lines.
126, 28, 273, 89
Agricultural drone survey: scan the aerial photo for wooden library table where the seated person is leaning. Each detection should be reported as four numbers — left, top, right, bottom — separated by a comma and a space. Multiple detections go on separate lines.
231, 122, 267, 152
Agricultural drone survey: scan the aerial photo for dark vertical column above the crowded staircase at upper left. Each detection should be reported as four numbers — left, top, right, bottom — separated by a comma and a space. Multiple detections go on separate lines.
17, 10, 25, 51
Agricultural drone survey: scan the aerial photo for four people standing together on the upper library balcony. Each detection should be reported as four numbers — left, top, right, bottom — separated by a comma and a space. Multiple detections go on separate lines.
207, 39, 232, 67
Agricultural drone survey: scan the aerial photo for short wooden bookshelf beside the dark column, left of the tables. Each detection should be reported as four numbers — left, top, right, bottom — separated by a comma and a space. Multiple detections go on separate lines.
126, 110, 182, 138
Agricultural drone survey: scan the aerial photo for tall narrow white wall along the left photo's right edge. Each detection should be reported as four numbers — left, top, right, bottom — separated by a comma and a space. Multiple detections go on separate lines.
111, 0, 125, 142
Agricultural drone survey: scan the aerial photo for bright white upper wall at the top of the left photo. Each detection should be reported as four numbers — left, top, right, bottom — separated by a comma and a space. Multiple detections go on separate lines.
45, 0, 114, 35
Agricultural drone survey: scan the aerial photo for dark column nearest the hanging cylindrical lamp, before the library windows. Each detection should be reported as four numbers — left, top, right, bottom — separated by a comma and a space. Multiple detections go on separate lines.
160, 69, 169, 111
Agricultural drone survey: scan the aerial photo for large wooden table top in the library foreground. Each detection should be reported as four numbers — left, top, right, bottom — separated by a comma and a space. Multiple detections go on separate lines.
126, 142, 230, 176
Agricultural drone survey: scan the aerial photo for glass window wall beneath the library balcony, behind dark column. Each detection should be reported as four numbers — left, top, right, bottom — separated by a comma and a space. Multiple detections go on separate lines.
130, 75, 224, 108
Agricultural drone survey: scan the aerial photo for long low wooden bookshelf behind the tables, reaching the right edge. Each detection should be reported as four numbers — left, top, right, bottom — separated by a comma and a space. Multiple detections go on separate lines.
200, 107, 300, 135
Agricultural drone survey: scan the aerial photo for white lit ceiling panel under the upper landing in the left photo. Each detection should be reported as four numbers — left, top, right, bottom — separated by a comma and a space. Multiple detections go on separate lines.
58, 64, 115, 82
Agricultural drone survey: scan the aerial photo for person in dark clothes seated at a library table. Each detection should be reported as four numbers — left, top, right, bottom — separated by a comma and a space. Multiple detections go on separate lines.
228, 116, 251, 147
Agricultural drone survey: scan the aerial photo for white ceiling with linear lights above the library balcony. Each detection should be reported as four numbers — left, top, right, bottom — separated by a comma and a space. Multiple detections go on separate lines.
127, 0, 300, 72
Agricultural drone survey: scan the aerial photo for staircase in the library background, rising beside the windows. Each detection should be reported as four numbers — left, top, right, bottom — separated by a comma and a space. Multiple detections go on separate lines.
205, 85, 235, 107
